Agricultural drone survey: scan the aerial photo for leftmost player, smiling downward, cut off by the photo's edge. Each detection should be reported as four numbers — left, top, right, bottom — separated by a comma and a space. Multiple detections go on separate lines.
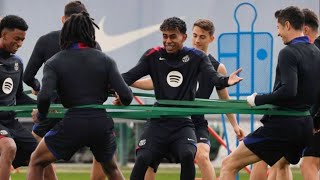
0, 15, 37, 179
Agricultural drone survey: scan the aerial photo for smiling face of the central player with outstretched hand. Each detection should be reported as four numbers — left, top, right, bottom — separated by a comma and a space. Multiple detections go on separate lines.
162, 29, 187, 53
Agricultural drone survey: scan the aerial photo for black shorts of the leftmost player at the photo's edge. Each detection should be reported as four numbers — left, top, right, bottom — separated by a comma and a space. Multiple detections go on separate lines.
0, 118, 38, 168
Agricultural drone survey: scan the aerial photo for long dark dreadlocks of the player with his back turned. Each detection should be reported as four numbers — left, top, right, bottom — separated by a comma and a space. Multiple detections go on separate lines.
60, 12, 97, 49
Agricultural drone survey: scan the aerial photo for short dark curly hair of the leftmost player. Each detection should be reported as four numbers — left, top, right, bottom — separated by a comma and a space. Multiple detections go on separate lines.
0, 15, 28, 37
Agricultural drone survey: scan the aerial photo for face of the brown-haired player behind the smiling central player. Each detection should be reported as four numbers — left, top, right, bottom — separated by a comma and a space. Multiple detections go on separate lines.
192, 26, 214, 51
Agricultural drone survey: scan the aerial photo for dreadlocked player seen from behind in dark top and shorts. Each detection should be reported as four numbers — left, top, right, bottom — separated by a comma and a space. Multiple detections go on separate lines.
28, 12, 132, 180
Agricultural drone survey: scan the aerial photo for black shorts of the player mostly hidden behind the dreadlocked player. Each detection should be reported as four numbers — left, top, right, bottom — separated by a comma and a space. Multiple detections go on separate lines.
32, 118, 62, 137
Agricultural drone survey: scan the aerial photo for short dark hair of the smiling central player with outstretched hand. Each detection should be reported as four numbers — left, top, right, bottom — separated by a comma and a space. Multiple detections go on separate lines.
160, 17, 187, 34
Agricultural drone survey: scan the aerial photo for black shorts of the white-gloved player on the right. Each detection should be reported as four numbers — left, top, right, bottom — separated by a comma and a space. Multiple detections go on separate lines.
243, 116, 313, 166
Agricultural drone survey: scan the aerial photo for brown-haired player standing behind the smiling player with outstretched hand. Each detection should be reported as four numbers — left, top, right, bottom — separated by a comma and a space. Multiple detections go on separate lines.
142, 19, 244, 180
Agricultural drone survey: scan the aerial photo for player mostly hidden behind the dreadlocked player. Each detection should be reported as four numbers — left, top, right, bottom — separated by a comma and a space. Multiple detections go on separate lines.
23, 1, 109, 180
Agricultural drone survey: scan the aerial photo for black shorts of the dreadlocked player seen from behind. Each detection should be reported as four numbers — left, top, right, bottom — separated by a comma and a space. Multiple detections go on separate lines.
44, 108, 116, 162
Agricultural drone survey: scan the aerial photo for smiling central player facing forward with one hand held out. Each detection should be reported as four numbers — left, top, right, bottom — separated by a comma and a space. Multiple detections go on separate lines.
123, 17, 242, 180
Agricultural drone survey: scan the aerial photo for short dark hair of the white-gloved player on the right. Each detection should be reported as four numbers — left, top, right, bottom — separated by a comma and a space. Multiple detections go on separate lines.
274, 6, 304, 30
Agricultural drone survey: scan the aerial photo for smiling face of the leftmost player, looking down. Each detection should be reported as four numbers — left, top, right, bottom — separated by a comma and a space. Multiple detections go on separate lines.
1, 29, 26, 54
